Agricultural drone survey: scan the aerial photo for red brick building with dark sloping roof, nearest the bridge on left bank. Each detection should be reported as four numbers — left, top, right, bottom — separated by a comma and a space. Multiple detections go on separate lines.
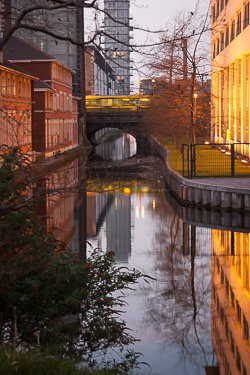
3, 37, 79, 157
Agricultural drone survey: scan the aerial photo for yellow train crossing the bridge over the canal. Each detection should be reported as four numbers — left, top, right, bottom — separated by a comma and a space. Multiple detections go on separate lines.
86, 95, 150, 112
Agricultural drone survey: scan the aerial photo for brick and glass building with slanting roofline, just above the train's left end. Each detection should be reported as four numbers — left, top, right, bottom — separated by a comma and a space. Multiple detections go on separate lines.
85, 46, 116, 95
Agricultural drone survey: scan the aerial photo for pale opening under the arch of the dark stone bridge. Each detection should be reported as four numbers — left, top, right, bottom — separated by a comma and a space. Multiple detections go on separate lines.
95, 134, 137, 161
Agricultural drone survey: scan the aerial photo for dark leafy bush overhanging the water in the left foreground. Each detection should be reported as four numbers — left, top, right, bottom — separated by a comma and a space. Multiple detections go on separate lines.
0, 149, 144, 374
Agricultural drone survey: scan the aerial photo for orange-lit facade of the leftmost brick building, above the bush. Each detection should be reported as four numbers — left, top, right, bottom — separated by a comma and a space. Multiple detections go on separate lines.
0, 61, 36, 157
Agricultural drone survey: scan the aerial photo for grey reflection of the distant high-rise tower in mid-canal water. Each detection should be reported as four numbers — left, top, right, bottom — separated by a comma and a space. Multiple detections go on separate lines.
106, 194, 131, 262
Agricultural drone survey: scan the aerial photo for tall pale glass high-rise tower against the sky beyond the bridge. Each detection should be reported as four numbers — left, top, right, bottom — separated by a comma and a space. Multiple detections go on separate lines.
104, 0, 131, 95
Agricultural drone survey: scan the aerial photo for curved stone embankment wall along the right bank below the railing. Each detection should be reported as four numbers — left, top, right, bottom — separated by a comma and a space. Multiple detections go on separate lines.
149, 137, 250, 211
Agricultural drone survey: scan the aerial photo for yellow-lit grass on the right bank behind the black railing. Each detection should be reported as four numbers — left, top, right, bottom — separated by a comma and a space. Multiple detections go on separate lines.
155, 137, 250, 177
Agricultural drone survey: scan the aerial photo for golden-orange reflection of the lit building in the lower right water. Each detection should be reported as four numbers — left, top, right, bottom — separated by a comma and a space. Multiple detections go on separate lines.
212, 230, 250, 375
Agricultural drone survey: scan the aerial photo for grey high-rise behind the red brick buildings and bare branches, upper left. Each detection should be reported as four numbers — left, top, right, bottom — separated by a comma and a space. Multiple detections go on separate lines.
8, 0, 83, 96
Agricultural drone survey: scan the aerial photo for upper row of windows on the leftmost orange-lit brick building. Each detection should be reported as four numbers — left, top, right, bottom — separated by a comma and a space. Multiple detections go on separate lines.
1, 73, 31, 99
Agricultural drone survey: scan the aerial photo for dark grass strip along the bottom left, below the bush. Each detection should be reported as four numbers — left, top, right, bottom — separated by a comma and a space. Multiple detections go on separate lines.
0, 350, 116, 375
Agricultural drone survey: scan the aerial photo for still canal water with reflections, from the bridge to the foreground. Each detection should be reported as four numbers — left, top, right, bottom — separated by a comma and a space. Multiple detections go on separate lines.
47, 135, 250, 375
